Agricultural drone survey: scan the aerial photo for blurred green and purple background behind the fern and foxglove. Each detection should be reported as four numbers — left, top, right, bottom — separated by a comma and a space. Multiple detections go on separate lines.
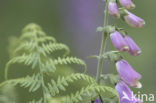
0, 0, 156, 102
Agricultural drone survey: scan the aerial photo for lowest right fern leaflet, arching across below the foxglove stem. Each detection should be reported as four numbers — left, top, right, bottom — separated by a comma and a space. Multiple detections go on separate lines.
66, 84, 118, 103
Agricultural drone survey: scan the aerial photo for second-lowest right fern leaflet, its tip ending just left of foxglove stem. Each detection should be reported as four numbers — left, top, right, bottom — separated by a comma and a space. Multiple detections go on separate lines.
48, 73, 96, 96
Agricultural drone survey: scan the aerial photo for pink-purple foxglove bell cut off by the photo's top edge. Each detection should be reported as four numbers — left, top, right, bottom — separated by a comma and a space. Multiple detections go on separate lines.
119, 0, 135, 9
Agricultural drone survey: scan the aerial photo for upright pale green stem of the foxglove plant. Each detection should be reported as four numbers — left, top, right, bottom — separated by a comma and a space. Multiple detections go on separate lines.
96, 0, 109, 83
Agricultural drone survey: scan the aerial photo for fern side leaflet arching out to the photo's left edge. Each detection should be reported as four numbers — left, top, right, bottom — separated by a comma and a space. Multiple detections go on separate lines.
0, 74, 41, 92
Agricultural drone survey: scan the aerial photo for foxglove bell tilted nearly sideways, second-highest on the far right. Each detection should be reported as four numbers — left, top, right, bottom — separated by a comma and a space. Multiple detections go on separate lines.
123, 11, 145, 28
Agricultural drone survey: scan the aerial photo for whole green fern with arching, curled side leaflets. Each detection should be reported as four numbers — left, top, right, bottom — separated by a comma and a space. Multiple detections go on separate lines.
0, 24, 117, 103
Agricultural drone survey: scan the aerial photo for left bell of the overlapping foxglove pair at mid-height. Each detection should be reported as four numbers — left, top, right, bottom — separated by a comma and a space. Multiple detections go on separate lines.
110, 31, 129, 51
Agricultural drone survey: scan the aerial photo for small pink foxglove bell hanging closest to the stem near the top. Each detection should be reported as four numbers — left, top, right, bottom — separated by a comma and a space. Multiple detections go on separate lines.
108, 1, 120, 18
